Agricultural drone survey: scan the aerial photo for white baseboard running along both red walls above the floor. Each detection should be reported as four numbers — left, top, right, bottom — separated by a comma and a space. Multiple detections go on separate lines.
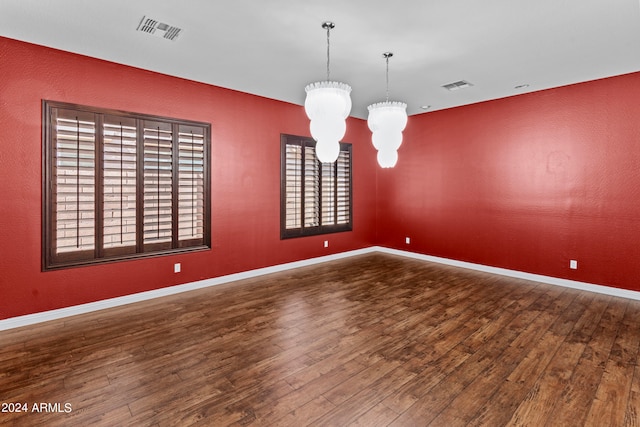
0, 246, 640, 331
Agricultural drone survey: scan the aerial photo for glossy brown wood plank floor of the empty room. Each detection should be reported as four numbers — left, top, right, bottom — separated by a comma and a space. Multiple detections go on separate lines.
0, 254, 640, 427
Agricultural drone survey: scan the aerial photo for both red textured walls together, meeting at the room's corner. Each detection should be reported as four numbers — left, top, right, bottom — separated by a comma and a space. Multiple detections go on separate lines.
0, 38, 640, 319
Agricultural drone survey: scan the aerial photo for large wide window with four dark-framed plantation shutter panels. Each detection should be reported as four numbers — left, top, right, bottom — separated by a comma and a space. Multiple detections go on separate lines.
43, 101, 211, 270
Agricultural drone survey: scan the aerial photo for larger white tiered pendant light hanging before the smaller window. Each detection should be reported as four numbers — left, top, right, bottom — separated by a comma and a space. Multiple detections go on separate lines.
304, 22, 351, 163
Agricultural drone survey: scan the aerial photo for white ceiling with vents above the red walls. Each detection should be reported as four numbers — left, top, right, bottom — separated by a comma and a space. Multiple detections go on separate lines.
0, 0, 640, 118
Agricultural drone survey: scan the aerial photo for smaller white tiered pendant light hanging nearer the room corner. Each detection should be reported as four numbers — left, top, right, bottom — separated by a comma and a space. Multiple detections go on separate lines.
367, 52, 407, 168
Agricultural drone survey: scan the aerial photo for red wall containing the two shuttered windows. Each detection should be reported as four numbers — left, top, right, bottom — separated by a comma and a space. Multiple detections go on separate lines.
0, 38, 376, 319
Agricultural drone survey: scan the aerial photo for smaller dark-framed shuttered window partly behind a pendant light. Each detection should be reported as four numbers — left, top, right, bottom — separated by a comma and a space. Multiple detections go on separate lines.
280, 135, 352, 239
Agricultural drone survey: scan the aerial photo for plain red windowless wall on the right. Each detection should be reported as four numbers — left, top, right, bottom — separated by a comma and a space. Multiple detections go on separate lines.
377, 73, 640, 290
